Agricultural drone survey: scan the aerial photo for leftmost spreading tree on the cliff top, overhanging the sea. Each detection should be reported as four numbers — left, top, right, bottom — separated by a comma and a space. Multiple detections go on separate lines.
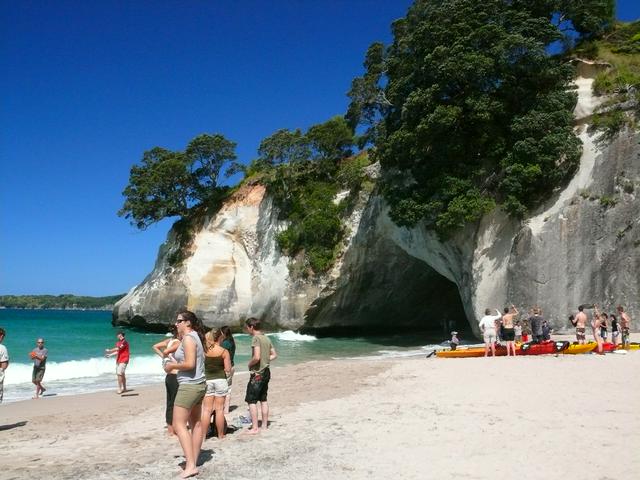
118, 134, 236, 230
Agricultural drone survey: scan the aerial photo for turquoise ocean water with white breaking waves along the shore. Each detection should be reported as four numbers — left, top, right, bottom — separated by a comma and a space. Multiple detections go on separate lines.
0, 309, 456, 402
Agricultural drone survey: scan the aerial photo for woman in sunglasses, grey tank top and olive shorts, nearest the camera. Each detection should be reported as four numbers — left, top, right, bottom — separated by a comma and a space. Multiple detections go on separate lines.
164, 310, 207, 478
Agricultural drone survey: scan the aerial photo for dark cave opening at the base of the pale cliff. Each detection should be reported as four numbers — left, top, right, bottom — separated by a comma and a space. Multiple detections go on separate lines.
301, 194, 471, 338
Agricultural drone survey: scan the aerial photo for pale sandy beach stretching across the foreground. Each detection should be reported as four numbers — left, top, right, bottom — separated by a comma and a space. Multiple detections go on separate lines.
0, 335, 640, 480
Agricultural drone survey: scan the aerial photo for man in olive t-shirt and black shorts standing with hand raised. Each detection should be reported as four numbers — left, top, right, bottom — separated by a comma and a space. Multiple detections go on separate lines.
245, 318, 278, 434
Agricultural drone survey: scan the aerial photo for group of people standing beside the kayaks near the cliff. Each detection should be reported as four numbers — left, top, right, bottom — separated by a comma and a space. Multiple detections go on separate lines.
472, 304, 631, 357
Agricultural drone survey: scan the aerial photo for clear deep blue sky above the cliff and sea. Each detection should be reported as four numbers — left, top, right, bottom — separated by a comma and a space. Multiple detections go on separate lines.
0, 0, 640, 295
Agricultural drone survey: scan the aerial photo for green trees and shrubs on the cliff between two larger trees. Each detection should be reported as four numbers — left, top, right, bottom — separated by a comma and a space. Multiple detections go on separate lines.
250, 116, 360, 273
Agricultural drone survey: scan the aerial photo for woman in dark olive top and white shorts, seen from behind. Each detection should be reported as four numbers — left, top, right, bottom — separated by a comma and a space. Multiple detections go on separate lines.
202, 329, 231, 441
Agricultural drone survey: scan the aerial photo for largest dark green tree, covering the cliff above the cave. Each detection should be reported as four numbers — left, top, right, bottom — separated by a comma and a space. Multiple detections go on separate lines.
347, 0, 613, 235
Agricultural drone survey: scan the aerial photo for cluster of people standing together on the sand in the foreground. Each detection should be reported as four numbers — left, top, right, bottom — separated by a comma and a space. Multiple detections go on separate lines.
153, 310, 277, 478
